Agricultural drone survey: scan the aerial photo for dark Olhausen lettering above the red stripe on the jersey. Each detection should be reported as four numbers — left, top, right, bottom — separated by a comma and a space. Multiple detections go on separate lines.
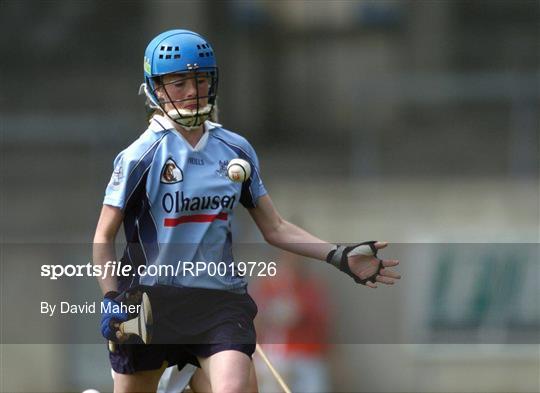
161, 191, 236, 213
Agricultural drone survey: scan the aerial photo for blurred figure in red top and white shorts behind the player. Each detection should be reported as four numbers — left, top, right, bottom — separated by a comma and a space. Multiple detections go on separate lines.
250, 253, 332, 393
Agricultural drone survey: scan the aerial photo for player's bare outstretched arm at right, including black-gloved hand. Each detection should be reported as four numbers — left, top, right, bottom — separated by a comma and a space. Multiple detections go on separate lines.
248, 194, 401, 288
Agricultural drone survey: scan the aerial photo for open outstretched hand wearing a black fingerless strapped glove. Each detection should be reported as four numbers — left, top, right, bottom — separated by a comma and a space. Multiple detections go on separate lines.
326, 241, 401, 288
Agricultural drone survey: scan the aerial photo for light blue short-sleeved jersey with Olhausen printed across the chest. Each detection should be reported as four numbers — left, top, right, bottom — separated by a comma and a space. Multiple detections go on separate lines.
103, 116, 266, 292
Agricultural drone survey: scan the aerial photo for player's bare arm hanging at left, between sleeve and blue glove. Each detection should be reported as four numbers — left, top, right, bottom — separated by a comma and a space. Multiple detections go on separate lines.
93, 205, 124, 294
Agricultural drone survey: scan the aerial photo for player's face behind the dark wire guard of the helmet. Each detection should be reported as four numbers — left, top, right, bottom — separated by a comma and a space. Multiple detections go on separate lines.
156, 72, 210, 111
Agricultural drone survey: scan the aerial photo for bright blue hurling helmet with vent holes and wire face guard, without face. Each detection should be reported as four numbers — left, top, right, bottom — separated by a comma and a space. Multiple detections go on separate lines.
143, 30, 218, 129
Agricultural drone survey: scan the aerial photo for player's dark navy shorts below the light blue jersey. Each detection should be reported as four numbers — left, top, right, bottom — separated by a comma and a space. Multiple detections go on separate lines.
109, 286, 257, 374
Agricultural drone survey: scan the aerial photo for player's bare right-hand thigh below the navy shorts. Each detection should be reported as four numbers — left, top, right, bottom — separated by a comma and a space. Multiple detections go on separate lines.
198, 350, 258, 393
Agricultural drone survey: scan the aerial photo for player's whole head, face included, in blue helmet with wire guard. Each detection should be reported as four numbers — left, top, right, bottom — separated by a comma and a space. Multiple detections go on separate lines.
143, 30, 218, 130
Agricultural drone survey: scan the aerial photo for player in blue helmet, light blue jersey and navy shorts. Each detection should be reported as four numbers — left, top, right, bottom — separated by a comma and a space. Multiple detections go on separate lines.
94, 30, 400, 393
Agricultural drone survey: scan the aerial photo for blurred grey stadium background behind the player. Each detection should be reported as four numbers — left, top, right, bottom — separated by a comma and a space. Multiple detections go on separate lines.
0, 0, 540, 392
